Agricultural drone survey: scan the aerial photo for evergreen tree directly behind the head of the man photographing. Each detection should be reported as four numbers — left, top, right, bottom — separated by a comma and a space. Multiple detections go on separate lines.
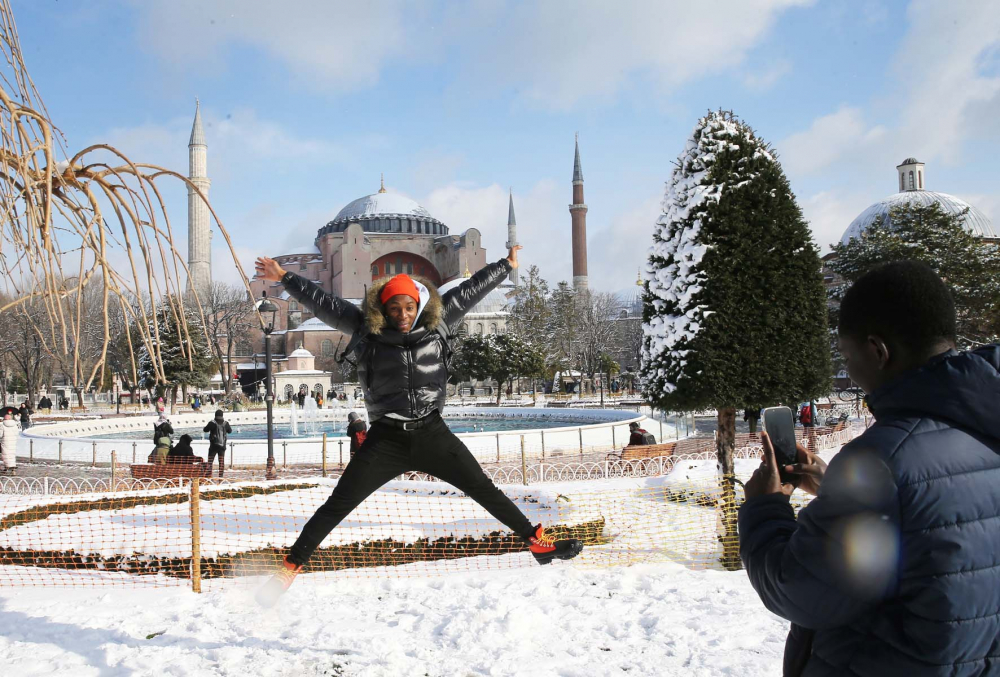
829, 202, 1000, 346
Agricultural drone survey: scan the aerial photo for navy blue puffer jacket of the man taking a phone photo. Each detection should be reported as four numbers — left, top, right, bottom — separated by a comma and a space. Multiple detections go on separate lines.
739, 345, 1000, 677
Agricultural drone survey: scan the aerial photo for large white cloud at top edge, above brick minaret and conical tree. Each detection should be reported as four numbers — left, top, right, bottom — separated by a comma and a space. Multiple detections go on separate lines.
448, 0, 809, 109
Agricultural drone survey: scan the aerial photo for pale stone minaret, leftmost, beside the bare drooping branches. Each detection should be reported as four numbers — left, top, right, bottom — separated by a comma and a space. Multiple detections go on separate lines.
187, 100, 212, 303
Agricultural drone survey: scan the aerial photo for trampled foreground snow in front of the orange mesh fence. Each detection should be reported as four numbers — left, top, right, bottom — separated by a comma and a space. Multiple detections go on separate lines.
0, 554, 786, 677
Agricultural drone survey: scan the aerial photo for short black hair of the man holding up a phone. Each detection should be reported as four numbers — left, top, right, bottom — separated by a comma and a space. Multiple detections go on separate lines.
838, 261, 956, 351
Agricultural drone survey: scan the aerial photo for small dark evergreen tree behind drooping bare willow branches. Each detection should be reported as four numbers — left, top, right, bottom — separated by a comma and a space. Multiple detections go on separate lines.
138, 304, 216, 410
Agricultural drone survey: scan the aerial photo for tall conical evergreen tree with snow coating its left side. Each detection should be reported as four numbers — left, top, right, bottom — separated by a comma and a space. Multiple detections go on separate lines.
641, 111, 830, 568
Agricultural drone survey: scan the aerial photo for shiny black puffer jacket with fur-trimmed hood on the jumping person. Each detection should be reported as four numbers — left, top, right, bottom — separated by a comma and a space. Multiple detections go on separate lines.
281, 259, 511, 421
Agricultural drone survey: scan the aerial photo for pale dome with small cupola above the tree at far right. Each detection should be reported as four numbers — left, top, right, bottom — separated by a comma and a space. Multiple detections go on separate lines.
840, 157, 1000, 244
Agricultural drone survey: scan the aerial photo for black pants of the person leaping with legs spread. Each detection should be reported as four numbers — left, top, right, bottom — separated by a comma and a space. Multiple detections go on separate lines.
288, 413, 535, 564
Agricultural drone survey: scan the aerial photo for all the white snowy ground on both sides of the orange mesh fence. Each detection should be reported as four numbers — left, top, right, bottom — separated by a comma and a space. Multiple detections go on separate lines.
0, 450, 852, 677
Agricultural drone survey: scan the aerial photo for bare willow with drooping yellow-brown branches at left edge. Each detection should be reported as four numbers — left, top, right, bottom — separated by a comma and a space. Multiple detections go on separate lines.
0, 0, 263, 398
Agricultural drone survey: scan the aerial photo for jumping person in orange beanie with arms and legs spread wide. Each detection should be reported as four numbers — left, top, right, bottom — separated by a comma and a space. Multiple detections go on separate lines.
256, 246, 583, 606
